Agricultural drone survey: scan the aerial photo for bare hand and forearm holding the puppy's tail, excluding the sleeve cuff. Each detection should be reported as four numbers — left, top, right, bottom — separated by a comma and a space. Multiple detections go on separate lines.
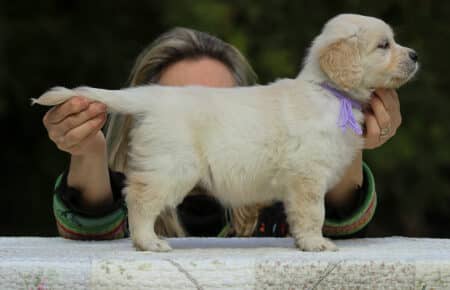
43, 97, 112, 209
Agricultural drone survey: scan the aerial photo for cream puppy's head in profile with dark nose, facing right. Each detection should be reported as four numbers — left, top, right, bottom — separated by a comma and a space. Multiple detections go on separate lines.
307, 14, 418, 101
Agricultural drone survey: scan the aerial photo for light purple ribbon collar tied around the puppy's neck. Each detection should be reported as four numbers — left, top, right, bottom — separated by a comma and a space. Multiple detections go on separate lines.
320, 82, 363, 135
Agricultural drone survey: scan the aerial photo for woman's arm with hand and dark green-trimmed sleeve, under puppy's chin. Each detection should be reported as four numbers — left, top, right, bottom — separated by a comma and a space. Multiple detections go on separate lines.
324, 89, 401, 236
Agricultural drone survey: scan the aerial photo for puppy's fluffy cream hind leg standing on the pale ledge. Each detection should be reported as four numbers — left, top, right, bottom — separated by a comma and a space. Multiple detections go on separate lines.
125, 172, 197, 252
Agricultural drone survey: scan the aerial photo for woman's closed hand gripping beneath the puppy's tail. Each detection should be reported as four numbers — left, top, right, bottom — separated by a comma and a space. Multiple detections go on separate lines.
42, 97, 106, 156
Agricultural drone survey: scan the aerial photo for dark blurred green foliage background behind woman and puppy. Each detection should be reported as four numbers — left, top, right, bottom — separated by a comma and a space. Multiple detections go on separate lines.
0, 0, 450, 238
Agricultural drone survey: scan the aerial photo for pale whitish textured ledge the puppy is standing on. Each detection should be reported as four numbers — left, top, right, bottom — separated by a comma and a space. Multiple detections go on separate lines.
0, 237, 450, 290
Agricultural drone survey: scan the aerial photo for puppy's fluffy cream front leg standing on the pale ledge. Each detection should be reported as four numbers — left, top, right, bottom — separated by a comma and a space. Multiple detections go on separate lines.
284, 178, 337, 251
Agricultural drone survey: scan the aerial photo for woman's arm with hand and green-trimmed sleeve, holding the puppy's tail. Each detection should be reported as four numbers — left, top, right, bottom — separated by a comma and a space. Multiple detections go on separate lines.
43, 97, 126, 239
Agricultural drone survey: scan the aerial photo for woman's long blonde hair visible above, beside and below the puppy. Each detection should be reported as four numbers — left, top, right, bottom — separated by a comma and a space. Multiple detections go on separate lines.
106, 28, 261, 237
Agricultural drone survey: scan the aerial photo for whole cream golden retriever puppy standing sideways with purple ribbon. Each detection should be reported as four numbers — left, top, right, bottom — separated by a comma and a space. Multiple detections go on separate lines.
33, 14, 418, 251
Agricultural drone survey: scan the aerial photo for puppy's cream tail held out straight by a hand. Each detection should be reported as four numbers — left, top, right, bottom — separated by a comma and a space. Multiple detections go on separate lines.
31, 87, 146, 114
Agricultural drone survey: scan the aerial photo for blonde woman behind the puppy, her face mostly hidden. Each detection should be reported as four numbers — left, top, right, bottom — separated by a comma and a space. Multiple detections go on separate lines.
43, 28, 401, 240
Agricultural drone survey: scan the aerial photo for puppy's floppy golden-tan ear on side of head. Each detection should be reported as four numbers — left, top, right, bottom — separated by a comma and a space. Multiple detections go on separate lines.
319, 35, 362, 90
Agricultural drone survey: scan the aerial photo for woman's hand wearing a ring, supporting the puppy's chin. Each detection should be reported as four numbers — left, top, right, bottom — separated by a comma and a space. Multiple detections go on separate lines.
363, 89, 402, 149
